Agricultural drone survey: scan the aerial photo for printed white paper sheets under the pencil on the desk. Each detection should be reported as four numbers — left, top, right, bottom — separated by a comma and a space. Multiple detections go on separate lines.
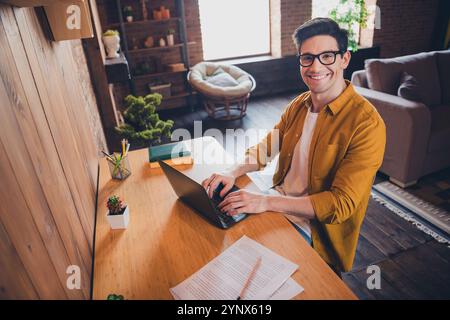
170, 236, 303, 300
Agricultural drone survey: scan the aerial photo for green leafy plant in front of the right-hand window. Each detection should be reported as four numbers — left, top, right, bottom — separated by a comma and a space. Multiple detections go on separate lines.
329, 0, 368, 52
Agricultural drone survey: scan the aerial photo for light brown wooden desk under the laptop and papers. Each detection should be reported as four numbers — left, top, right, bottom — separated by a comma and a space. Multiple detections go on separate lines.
93, 138, 356, 300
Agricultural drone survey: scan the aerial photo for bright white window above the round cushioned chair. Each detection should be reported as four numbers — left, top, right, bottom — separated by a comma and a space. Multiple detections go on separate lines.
199, 0, 270, 60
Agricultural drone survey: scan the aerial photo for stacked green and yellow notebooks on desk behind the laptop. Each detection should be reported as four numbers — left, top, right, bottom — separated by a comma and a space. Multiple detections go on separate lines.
148, 141, 193, 168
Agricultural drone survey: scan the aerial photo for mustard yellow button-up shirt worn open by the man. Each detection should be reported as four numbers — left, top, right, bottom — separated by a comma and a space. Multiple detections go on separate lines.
246, 80, 386, 271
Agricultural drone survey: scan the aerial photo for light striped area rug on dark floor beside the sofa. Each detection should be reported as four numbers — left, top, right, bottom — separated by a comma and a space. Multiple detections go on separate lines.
372, 181, 450, 244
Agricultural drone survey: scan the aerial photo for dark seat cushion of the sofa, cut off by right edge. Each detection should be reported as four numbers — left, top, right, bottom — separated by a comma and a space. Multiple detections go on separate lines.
428, 105, 450, 152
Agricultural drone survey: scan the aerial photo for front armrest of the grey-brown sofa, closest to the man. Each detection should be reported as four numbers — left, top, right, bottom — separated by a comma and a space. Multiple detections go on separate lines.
355, 87, 431, 183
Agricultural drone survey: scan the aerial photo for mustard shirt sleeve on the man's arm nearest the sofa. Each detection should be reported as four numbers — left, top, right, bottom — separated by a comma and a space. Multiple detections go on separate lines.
309, 118, 386, 224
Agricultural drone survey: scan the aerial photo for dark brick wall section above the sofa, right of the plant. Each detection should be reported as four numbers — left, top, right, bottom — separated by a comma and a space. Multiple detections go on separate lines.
373, 0, 439, 58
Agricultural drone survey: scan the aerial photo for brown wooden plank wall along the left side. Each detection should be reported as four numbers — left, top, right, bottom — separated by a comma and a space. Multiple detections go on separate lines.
0, 4, 98, 299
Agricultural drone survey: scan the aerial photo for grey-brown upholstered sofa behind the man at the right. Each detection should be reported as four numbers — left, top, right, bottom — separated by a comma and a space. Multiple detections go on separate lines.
351, 50, 450, 188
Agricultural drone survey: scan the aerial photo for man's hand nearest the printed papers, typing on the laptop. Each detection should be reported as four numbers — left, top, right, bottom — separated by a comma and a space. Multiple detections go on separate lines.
218, 190, 269, 215
